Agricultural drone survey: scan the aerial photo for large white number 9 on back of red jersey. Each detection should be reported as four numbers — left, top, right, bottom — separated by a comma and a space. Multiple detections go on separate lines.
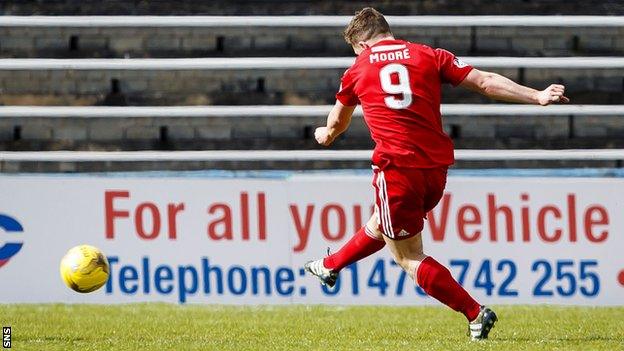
379, 63, 412, 110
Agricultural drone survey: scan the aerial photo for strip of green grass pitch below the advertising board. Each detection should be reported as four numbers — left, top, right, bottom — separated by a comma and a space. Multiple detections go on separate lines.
0, 304, 624, 351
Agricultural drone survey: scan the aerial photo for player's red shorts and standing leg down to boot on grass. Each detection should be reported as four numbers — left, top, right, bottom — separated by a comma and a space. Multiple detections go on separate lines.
376, 168, 497, 339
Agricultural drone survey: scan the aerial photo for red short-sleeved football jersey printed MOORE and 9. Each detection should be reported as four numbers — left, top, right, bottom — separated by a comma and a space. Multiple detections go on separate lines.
336, 40, 472, 168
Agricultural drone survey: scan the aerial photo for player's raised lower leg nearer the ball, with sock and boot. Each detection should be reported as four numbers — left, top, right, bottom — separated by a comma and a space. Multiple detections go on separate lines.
304, 216, 386, 287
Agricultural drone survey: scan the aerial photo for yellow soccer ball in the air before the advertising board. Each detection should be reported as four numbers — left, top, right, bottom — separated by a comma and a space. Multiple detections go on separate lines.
61, 245, 110, 293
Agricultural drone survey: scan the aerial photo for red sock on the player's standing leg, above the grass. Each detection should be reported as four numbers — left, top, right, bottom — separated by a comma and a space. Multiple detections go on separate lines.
416, 257, 481, 321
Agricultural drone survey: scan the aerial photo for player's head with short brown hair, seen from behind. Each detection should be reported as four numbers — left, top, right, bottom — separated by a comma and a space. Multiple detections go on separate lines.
343, 7, 392, 45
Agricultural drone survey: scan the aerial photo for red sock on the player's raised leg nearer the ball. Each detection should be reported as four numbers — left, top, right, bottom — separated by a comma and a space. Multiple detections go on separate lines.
323, 226, 386, 271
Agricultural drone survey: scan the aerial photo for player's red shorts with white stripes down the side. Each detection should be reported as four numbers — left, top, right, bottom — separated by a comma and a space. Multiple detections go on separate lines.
373, 166, 448, 240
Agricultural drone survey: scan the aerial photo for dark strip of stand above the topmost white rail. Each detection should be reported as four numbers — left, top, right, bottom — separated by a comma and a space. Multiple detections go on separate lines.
0, 0, 624, 15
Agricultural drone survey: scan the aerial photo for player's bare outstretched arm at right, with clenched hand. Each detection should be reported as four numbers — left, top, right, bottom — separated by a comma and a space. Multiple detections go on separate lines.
460, 69, 570, 106
